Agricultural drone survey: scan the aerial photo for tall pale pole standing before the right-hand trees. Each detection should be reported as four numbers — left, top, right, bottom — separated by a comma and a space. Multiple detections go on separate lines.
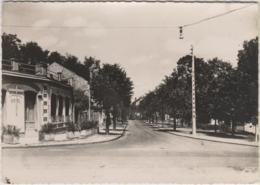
191, 45, 196, 136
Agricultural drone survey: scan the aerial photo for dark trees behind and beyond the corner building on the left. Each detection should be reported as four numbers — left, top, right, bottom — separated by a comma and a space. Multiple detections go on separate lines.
2, 33, 133, 133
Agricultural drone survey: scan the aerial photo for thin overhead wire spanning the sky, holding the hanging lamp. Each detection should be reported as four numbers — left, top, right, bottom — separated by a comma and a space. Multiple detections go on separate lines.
2, 4, 255, 29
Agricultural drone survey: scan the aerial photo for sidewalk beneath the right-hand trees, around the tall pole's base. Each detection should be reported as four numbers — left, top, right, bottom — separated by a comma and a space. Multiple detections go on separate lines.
149, 124, 259, 147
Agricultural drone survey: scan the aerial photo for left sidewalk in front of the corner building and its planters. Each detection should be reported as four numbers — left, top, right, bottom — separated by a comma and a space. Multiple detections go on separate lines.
1, 124, 127, 148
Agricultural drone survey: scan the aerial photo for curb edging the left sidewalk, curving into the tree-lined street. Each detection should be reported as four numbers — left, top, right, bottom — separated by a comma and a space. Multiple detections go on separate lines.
1, 124, 128, 149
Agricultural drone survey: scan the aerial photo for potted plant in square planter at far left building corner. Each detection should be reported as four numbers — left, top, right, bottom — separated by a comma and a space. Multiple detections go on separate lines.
2, 125, 20, 144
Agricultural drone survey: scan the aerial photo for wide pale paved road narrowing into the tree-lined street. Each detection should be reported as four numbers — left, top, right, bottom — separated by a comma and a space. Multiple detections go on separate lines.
2, 121, 258, 183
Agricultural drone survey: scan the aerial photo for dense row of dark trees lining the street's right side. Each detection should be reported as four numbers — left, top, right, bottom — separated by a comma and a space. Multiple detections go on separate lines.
139, 38, 258, 133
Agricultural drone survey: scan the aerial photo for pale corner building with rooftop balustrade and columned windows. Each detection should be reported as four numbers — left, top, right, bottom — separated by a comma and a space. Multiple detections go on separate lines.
2, 60, 74, 142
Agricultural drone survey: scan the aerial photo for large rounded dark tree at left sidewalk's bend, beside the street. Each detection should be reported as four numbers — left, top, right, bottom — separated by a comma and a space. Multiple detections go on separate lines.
92, 64, 133, 133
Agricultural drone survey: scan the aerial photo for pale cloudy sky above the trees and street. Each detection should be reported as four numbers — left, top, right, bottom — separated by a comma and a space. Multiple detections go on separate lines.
2, 2, 258, 97
